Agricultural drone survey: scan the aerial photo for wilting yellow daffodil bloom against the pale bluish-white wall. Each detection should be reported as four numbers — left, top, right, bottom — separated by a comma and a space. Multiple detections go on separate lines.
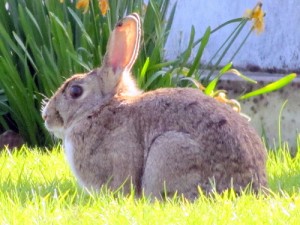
244, 2, 265, 34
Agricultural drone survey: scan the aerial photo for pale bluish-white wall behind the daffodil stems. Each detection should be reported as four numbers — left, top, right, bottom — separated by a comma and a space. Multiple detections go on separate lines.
166, 0, 300, 70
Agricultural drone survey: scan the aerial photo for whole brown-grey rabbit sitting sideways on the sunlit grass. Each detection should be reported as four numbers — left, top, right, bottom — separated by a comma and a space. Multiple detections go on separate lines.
42, 13, 267, 199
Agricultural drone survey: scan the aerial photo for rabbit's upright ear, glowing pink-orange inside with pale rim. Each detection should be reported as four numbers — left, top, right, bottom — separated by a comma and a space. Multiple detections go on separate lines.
105, 13, 141, 71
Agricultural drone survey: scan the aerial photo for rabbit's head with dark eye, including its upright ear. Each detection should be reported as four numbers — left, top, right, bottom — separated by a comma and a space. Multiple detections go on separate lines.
42, 14, 141, 138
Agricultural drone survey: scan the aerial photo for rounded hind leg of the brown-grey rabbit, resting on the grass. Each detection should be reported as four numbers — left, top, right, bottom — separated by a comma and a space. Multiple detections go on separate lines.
142, 131, 208, 199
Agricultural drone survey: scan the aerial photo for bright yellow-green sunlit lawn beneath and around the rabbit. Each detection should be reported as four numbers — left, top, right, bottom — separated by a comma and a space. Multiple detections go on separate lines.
0, 147, 300, 224
